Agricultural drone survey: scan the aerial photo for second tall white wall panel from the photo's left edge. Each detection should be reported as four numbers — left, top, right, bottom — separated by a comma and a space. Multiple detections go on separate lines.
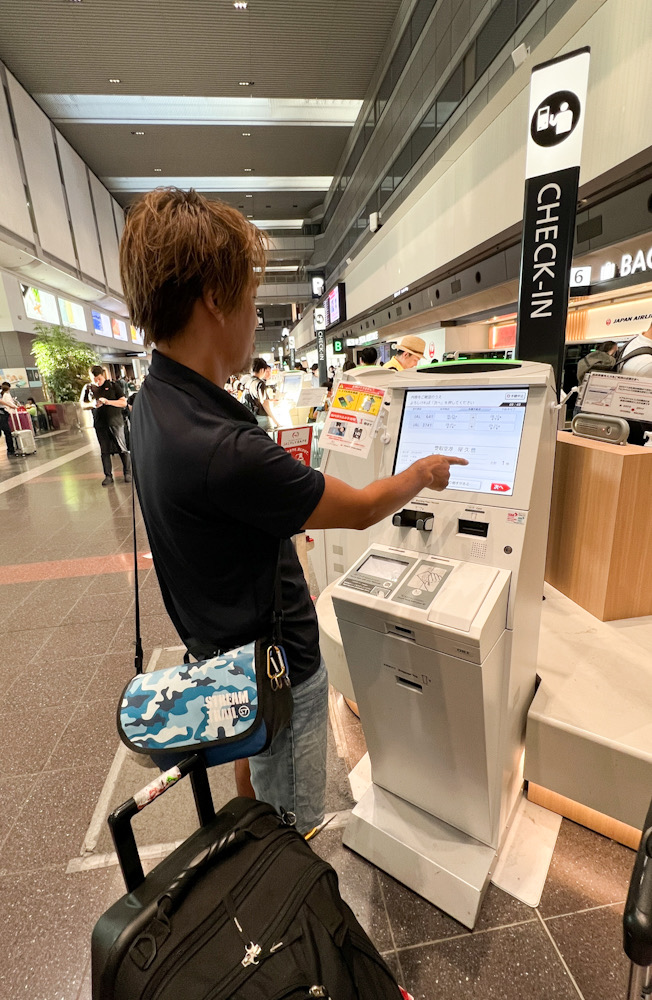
7, 73, 77, 267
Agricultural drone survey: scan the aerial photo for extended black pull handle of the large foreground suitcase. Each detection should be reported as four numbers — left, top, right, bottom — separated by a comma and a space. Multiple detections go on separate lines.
107, 754, 215, 892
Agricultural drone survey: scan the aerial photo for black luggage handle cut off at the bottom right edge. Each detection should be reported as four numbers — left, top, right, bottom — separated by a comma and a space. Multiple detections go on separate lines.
623, 802, 652, 997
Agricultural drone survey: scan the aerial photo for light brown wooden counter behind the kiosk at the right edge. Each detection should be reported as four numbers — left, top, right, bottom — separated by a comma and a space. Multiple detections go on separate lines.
546, 433, 652, 621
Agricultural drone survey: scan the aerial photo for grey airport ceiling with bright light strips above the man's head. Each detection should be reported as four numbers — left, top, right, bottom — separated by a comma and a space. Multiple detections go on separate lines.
0, 0, 410, 229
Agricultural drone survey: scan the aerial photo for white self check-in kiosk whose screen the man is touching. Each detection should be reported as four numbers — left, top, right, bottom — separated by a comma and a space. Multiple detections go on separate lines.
332, 362, 557, 927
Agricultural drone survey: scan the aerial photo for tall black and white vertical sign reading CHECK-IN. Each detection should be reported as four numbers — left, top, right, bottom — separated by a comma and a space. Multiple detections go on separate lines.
516, 48, 590, 393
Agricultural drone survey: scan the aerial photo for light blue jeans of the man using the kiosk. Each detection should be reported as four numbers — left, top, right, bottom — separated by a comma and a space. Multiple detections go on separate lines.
249, 660, 328, 834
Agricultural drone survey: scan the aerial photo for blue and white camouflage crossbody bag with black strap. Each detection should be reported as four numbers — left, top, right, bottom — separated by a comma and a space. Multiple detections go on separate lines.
117, 480, 292, 769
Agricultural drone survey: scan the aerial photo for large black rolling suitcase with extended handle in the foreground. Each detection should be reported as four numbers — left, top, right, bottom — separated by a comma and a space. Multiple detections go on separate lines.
92, 756, 401, 1000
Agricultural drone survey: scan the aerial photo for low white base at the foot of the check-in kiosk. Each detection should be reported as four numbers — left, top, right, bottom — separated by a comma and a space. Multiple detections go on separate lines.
343, 785, 497, 930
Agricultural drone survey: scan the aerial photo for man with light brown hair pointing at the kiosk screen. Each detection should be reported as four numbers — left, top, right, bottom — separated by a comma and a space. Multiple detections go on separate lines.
120, 188, 464, 833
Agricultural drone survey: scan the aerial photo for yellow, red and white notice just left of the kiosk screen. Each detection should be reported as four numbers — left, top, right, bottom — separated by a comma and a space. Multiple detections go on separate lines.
319, 382, 385, 458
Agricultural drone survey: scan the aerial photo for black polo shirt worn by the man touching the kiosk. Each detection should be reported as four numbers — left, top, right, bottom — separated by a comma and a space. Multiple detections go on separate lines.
131, 351, 324, 684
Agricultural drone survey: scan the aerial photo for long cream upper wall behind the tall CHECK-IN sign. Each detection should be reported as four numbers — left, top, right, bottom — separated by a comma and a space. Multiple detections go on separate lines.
344, 0, 652, 316
